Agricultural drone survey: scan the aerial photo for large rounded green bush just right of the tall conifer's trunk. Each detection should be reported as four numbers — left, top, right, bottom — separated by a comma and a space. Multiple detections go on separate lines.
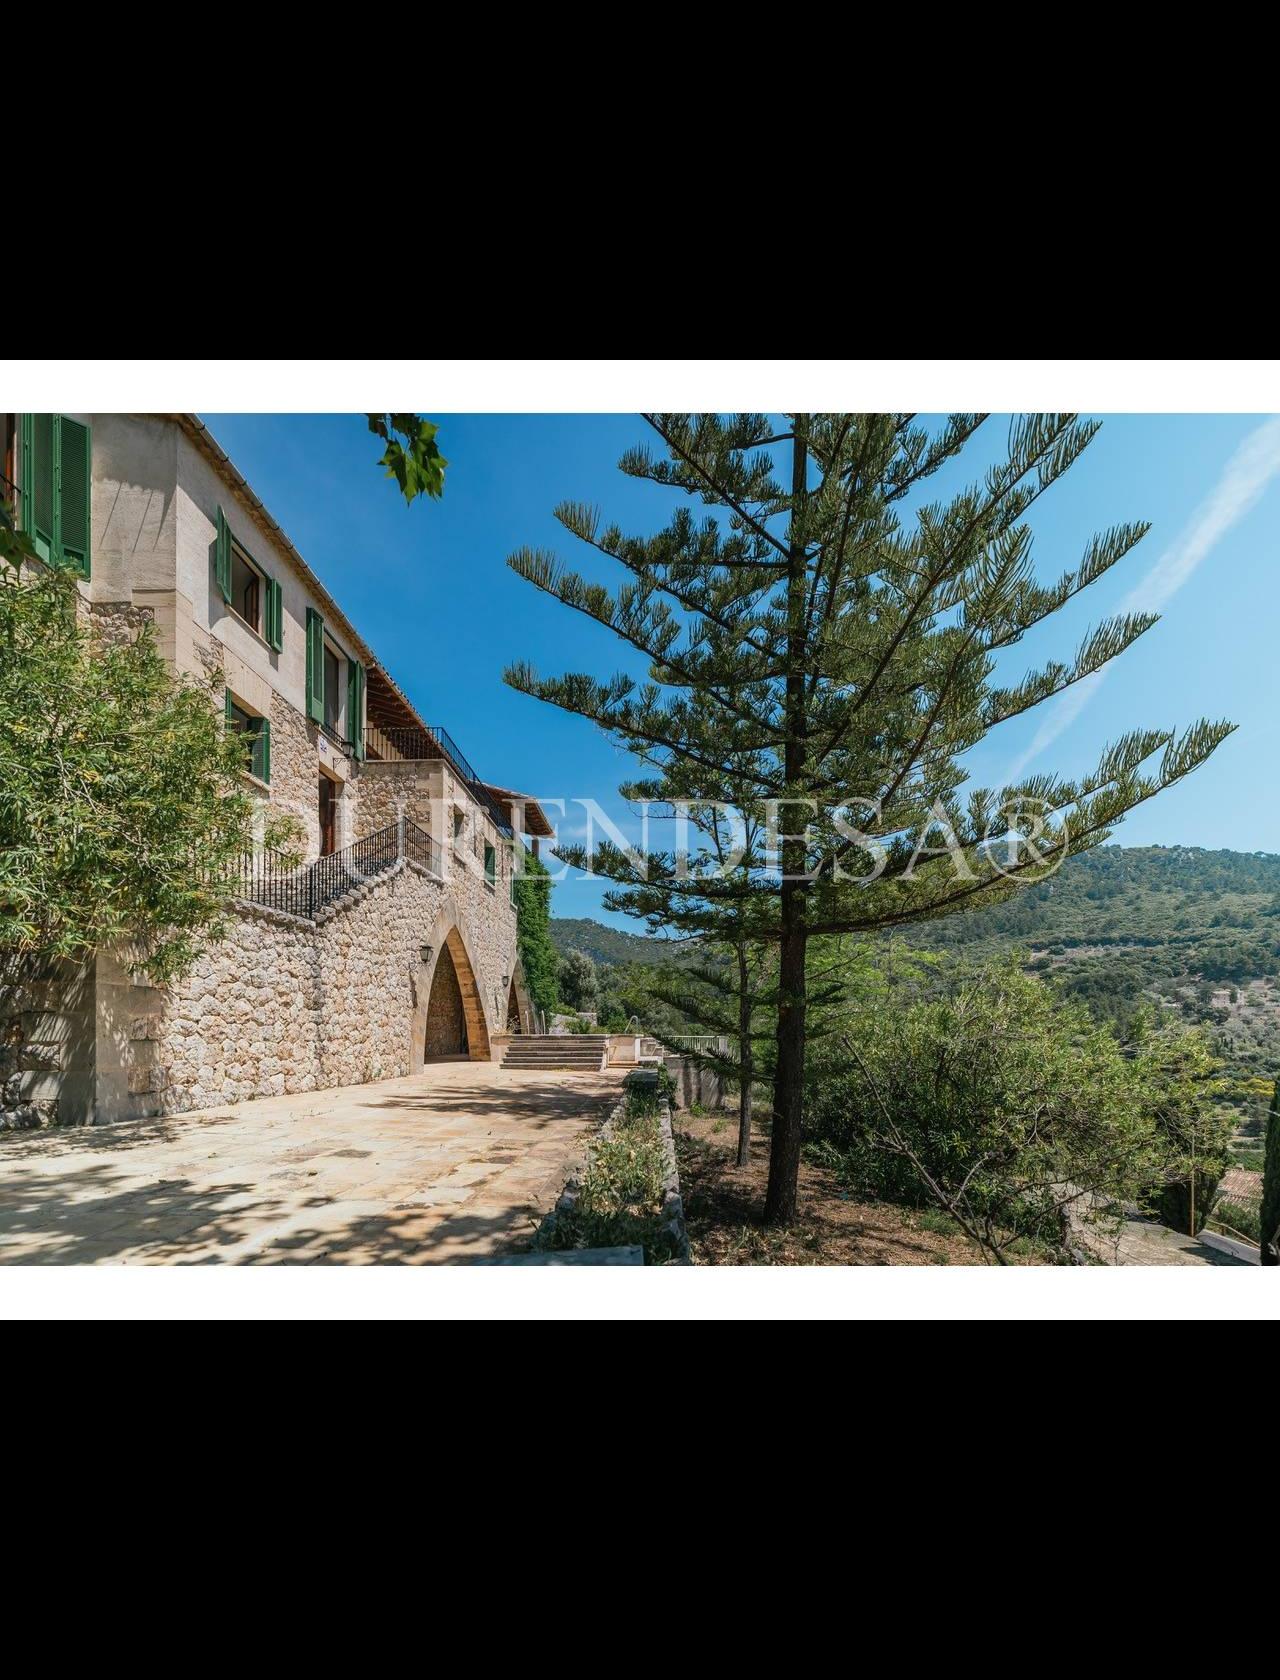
806, 959, 1221, 1260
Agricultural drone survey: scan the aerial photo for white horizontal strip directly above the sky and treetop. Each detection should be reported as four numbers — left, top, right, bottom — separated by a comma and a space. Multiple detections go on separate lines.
0, 358, 1280, 415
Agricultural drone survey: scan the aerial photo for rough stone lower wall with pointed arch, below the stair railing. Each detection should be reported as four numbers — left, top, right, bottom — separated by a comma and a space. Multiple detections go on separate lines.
0, 840, 517, 1127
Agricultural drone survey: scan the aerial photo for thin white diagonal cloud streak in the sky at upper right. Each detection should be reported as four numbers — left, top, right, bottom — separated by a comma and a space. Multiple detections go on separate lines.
1005, 415, 1280, 785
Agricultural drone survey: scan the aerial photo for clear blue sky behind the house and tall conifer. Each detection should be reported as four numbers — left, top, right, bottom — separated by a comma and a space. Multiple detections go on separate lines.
202, 413, 1280, 921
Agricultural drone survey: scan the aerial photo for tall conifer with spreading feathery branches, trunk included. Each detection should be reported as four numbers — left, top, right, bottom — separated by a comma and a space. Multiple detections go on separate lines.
506, 413, 1231, 1223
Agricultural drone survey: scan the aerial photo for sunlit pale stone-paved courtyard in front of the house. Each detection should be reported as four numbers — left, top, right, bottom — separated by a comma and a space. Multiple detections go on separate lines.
0, 1062, 620, 1265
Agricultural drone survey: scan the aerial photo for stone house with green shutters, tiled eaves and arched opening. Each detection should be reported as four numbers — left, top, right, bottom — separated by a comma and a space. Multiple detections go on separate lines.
0, 415, 551, 1124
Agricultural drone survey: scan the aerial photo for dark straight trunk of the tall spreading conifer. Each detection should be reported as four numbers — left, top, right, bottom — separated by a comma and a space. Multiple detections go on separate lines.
764, 415, 808, 1225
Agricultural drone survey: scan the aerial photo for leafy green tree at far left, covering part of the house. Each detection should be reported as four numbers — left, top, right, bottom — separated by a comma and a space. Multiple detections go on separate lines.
0, 526, 279, 979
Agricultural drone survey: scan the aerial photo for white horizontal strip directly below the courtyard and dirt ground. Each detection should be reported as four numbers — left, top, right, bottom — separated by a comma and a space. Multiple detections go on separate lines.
0, 1265, 1280, 1320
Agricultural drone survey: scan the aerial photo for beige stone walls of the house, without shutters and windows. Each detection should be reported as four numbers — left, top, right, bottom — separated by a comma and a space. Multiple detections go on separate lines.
0, 415, 527, 1127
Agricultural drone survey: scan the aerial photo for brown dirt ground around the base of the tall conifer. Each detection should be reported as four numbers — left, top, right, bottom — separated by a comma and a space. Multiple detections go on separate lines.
674, 1110, 983, 1265
